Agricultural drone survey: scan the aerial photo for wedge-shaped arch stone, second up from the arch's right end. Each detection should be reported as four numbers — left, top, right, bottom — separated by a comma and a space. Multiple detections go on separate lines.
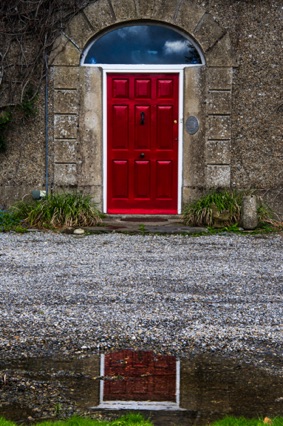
193, 13, 225, 52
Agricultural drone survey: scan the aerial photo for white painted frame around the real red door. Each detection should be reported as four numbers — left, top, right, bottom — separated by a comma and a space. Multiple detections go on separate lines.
102, 65, 185, 214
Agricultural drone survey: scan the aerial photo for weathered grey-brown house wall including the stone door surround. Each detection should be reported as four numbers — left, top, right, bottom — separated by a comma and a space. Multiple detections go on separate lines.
0, 0, 283, 213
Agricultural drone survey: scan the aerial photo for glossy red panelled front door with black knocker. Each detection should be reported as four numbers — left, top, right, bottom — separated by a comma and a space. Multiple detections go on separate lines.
107, 73, 178, 214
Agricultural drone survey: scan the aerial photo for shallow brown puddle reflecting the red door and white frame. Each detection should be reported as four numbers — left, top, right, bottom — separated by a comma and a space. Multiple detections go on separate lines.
0, 350, 283, 426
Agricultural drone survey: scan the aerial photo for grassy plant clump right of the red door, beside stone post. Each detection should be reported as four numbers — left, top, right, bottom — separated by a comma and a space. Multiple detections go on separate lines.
183, 190, 243, 228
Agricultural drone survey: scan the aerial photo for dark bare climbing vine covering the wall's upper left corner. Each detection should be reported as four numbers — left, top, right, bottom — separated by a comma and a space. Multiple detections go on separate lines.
0, 0, 96, 110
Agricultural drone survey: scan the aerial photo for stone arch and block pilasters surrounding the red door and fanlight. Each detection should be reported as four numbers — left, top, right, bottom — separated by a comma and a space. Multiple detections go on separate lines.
50, 0, 234, 212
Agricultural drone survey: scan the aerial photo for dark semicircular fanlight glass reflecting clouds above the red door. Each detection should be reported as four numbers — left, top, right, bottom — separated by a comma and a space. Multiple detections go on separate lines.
85, 25, 202, 65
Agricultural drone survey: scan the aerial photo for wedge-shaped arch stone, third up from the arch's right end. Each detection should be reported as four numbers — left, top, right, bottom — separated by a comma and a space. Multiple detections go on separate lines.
175, 0, 205, 33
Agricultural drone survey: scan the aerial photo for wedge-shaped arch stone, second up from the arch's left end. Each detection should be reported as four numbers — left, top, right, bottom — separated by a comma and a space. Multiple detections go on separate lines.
66, 12, 93, 51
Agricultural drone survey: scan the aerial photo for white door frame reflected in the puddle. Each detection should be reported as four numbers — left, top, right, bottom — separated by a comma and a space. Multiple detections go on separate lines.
91, 354, 182, 411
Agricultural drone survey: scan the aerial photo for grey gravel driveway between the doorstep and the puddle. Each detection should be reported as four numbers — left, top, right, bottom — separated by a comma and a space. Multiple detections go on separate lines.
0, 232, 283, 368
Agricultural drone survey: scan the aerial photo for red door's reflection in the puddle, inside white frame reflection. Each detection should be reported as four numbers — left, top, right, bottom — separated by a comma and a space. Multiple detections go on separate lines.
103, 350, 176, 402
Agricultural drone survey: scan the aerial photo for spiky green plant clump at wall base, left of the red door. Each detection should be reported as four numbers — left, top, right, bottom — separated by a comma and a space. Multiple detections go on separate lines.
12, 192, 101, 229
